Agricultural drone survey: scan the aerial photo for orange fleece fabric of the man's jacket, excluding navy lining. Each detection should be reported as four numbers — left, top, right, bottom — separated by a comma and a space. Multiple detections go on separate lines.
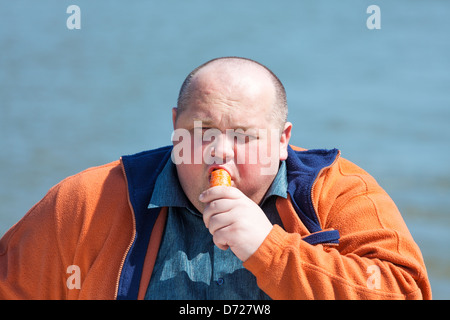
0, 149, 431, 299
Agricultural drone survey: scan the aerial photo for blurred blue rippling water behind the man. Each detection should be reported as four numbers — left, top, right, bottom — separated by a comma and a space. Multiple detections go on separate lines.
0, 0, 450, 299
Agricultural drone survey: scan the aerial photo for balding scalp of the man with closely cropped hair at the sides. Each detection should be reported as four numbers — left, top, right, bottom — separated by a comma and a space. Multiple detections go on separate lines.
177, 57, 287, 128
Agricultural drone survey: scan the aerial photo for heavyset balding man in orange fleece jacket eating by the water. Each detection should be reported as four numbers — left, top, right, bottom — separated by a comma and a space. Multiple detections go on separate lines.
0, 57, 431, 299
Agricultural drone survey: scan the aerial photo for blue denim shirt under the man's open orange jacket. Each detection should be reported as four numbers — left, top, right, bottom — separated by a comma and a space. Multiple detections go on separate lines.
145, 159, 287, 300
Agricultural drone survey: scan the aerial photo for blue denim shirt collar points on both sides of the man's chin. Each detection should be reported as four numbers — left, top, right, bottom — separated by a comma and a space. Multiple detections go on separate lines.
148, 159, 288, 211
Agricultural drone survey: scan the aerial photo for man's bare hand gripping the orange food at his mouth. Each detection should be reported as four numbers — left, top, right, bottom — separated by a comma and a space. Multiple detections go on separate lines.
199, 187, 273, 261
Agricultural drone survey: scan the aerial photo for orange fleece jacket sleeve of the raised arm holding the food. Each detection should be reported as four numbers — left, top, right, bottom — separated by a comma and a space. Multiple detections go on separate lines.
244, 159, 431, 299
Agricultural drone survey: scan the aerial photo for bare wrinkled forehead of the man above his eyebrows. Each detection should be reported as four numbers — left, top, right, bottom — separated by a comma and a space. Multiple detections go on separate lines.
178, 65, 275, 127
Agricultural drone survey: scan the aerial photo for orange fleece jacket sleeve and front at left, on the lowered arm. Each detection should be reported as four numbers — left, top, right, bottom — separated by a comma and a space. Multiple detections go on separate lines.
0, 162, 133, 299
